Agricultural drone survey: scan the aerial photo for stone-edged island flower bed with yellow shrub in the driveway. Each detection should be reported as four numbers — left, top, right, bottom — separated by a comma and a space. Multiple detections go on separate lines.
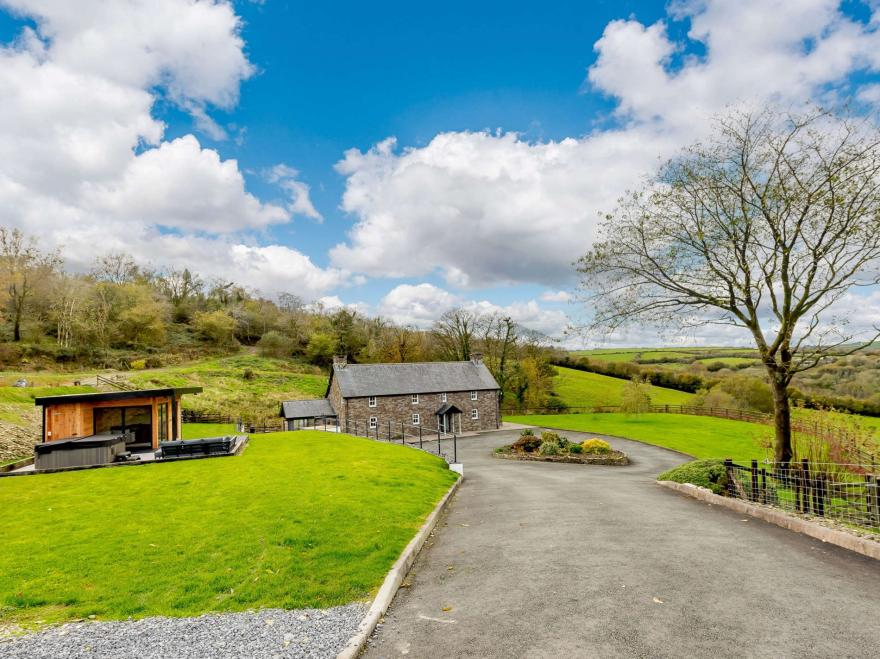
495, 429, 629, 465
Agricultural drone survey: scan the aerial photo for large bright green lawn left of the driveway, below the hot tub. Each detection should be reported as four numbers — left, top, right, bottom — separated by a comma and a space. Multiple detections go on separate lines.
0, 431, 455, 625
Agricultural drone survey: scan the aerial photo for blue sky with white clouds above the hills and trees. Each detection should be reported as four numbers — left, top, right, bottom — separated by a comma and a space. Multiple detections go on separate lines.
0, 0, 880, 345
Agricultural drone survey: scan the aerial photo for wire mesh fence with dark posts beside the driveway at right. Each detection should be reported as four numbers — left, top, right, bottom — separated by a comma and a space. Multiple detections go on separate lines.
724, 460, 880, 531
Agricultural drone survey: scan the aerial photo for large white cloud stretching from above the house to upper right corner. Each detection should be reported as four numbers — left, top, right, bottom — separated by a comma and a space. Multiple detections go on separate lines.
331, 0, 880, 286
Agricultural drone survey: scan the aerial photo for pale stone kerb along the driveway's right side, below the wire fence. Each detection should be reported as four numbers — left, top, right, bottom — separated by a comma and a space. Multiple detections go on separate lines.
657, 481, 880, 560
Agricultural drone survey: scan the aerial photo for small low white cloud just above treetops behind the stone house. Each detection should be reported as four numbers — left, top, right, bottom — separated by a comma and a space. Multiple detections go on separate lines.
379, 284, 568, 337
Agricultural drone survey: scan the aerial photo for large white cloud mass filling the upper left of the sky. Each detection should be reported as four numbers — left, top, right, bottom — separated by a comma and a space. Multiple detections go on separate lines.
0, 0, 348, 297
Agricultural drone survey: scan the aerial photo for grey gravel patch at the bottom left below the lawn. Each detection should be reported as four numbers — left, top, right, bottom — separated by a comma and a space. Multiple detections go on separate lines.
0, 604, 368, 659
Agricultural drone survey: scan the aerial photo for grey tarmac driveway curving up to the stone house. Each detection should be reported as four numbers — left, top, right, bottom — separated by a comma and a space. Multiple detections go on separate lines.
365, 432, 880, 659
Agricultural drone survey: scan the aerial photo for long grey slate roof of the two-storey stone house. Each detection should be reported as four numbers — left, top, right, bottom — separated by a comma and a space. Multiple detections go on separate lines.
333, 361, 499, 398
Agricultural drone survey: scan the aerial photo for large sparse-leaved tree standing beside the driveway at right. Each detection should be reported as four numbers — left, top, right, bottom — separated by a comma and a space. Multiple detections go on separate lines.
578, 111, 880, 462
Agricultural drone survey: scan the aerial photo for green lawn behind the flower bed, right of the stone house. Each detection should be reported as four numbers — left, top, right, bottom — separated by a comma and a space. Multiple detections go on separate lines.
504, 413, 766, 460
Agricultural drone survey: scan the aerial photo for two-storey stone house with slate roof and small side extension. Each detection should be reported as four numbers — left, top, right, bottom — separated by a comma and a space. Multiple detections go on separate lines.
281, 354, 501, 432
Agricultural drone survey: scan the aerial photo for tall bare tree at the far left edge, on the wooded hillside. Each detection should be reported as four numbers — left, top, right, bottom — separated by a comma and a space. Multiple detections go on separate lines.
0, 227, 61, 341
